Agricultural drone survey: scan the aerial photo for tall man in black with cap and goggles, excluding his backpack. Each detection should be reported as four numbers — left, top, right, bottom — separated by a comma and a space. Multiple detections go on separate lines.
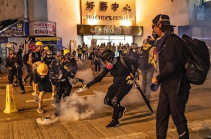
152, 14, 190, 139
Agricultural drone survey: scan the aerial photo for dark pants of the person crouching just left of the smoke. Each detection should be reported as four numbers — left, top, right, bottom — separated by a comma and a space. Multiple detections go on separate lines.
54, 81, 72, 116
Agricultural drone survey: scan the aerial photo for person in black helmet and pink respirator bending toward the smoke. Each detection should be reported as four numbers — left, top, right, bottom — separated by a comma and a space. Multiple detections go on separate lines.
84, 50, 138, 127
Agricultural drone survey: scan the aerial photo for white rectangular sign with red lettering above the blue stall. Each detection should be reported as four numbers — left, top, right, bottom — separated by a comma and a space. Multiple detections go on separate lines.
29, 21, 56, 36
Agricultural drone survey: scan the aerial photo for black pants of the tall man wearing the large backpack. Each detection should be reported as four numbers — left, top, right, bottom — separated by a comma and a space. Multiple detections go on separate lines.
156, 79, 190, 139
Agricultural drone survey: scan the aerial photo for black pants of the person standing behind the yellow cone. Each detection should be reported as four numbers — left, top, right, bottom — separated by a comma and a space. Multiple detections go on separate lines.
8, 68, 25, 91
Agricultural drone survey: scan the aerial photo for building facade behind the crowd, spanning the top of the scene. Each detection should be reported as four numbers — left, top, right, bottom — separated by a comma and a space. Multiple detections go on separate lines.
0, 0, 211, 49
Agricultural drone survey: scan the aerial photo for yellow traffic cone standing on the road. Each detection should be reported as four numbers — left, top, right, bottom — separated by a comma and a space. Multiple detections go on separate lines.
4, 84, 18, 113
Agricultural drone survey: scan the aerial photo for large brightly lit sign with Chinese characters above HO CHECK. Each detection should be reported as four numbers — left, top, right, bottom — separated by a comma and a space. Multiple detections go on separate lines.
81, 0, 136, 26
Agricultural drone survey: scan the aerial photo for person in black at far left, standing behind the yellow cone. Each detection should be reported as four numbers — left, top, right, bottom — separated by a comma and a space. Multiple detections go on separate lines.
6, 50, 25, 94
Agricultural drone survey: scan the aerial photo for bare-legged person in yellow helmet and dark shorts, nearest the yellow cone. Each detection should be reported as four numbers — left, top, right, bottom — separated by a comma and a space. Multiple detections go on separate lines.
34, 62, 52, 113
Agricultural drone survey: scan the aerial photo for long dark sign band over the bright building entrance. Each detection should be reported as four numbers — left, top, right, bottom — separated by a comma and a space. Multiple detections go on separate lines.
77, 25, 143, 36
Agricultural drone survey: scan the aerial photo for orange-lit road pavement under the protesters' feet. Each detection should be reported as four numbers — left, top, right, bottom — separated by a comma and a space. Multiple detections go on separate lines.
0, 69, 211, 139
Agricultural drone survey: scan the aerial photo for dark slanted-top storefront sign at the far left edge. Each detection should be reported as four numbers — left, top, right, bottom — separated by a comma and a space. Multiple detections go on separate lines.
0, 21, 24, 37
